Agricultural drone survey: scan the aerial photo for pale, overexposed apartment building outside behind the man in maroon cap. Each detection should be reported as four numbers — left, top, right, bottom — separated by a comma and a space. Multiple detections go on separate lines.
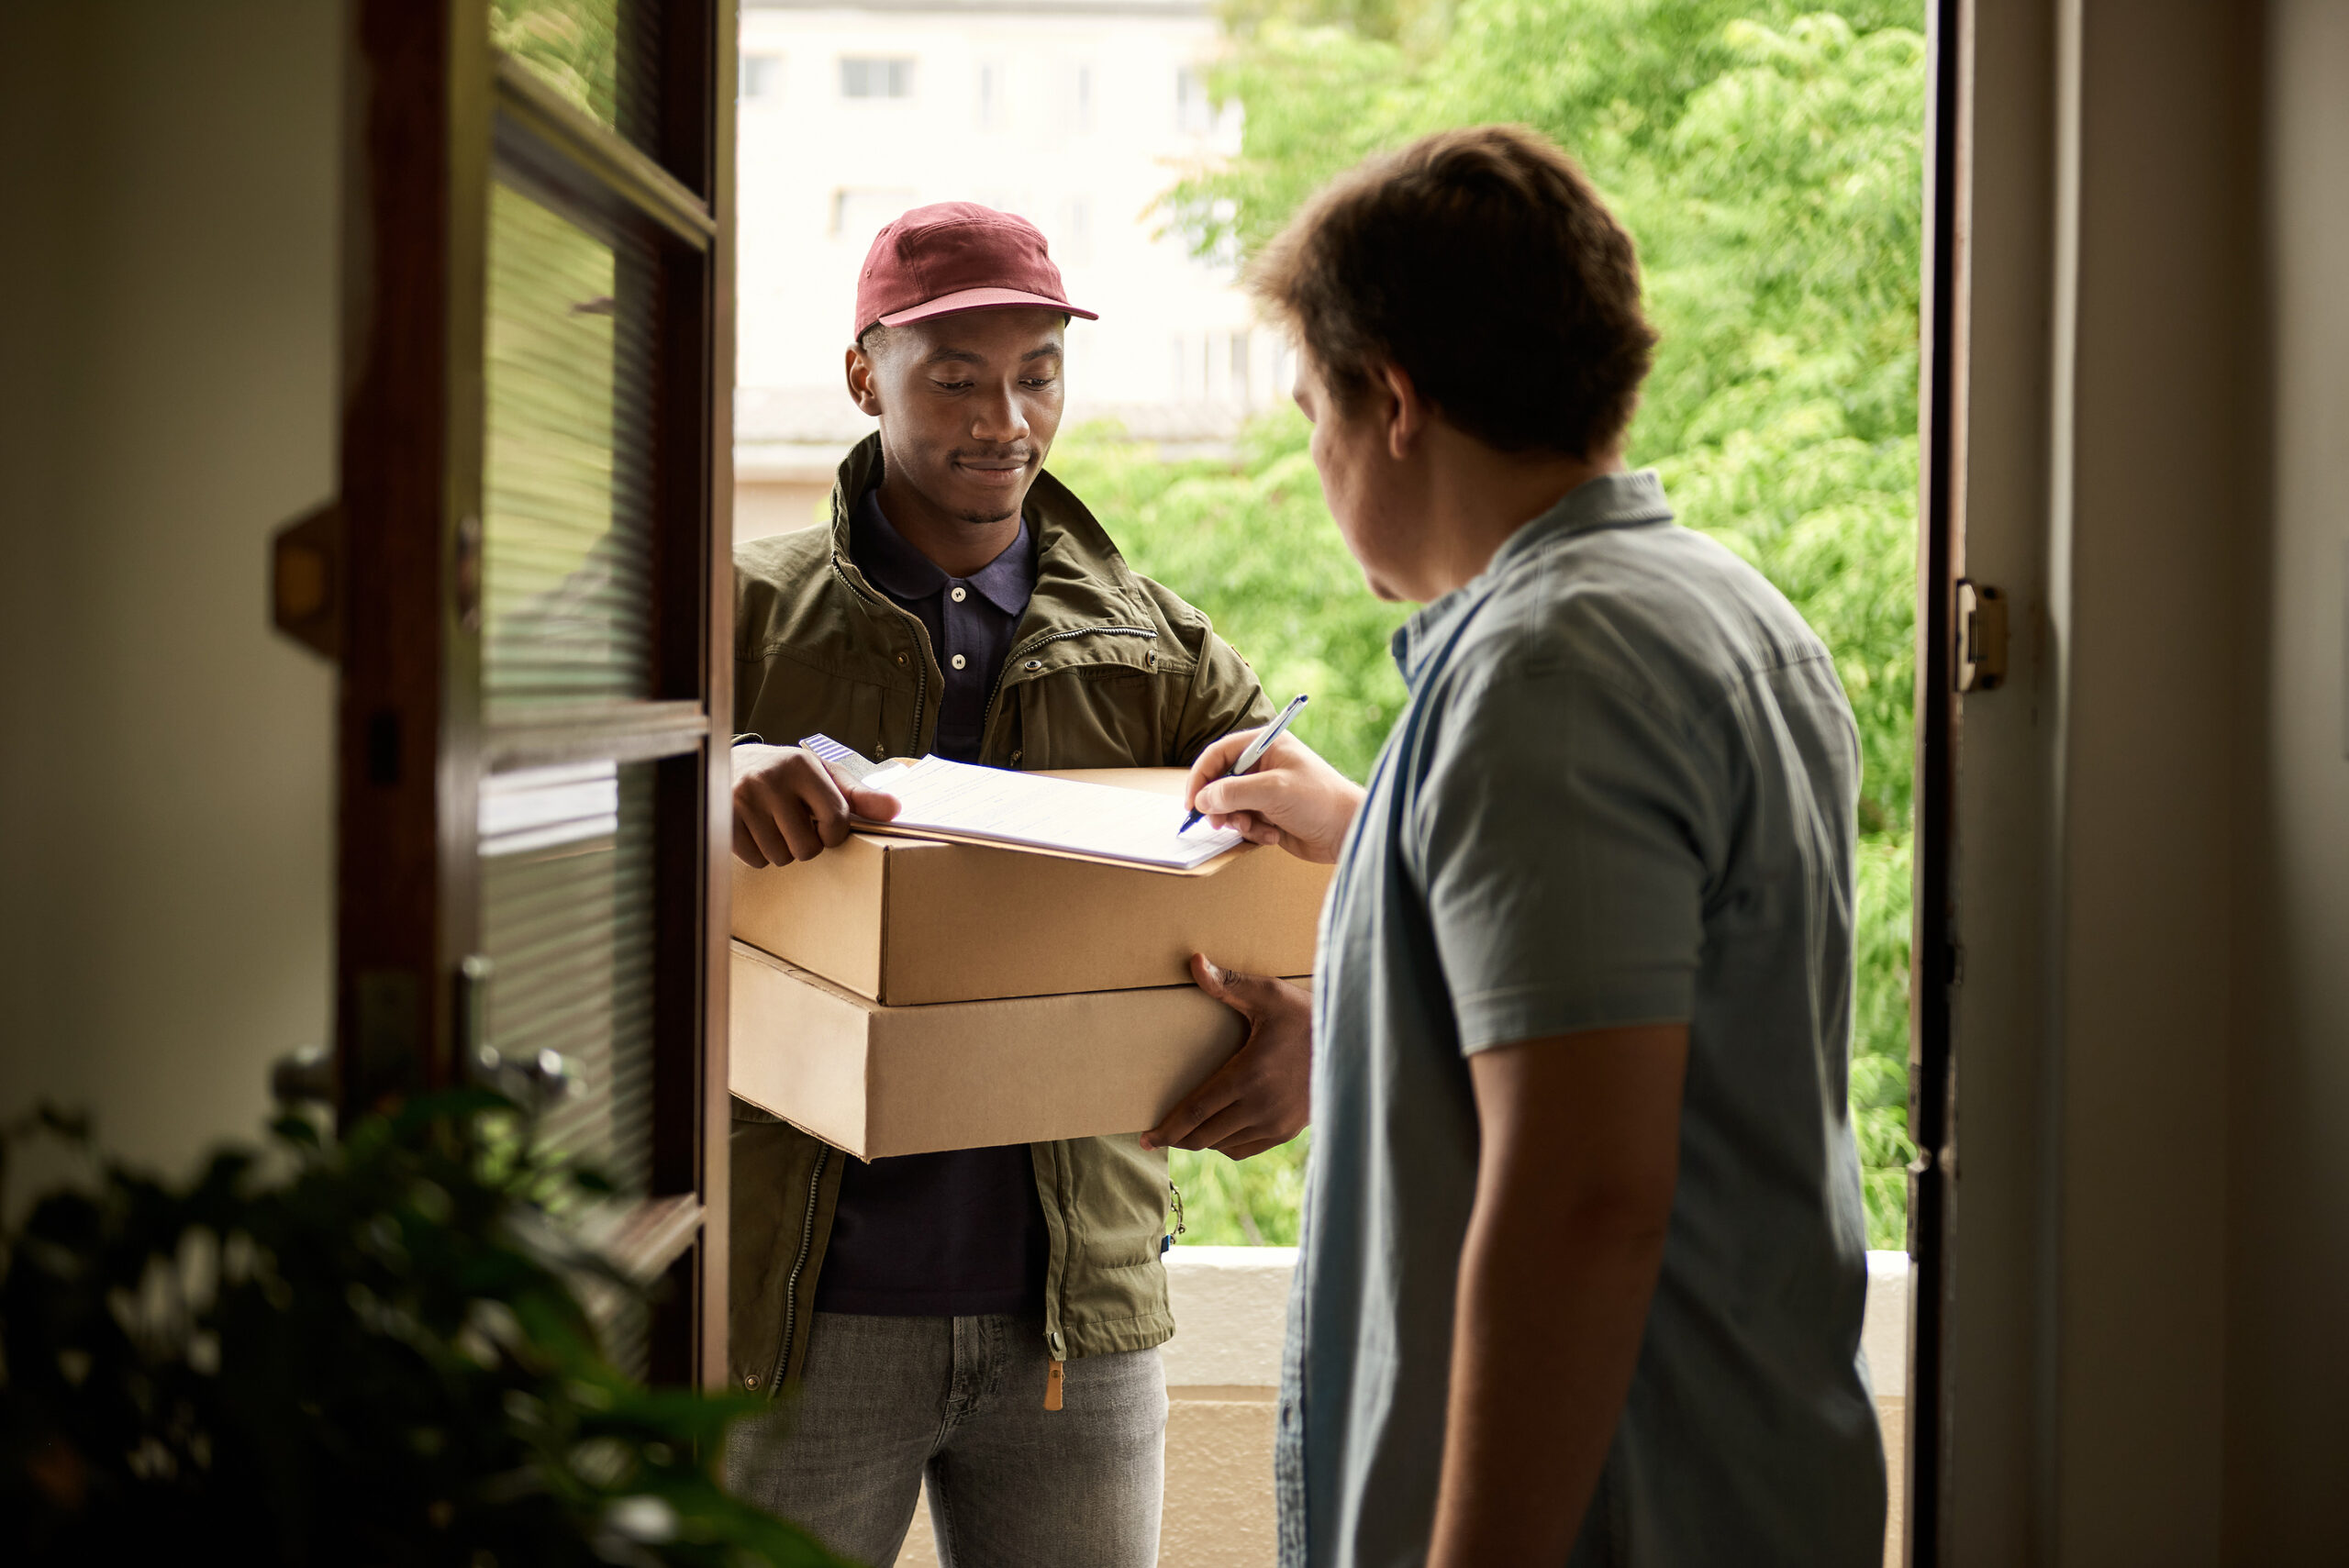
735, 0, 1287, 538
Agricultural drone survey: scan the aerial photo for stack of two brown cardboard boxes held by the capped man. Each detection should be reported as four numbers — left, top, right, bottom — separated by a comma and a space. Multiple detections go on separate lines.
730, 768, 1330, 1160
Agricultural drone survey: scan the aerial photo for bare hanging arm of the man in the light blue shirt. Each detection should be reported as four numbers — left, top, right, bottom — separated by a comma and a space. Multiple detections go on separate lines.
1428, 1023, 1689, 1568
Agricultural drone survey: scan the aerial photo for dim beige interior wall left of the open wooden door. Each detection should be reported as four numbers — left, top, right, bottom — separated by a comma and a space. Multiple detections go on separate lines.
0, 0, 343, 1164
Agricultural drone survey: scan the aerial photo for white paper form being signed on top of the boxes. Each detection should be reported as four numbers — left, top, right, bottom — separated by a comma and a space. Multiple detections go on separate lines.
864, 756, 1241, 871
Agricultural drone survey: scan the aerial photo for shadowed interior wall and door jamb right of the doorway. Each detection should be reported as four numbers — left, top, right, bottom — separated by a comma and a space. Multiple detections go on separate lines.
1945, 0, 2349, 1568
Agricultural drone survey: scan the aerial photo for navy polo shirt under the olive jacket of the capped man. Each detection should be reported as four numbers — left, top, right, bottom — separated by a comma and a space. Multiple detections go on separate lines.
815, 491, 1052, 1317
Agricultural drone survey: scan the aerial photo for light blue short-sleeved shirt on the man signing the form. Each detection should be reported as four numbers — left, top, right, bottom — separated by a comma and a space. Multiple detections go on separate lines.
1278, 472, 1884, 1568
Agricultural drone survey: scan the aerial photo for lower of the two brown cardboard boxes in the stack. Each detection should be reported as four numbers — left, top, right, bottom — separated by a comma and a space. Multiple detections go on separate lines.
729, 941, 1297, 1160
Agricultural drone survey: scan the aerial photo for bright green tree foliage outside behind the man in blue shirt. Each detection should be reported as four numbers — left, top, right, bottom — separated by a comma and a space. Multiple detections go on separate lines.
1099, 0, 1924, 1247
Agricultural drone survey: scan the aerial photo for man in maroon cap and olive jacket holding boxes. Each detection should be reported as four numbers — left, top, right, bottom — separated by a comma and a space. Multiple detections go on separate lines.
729, 202, 1308, 1568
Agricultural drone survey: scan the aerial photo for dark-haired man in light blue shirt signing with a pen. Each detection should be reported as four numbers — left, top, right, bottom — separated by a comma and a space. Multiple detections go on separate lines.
1161, 127, 1884, 1568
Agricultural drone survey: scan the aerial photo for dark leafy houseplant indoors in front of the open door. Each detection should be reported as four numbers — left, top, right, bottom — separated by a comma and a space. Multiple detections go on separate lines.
0, 1092, 836, 1568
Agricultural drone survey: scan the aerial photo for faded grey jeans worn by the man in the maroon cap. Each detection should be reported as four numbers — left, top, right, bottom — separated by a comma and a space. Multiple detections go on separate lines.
726, 1312, 1167, 1568
